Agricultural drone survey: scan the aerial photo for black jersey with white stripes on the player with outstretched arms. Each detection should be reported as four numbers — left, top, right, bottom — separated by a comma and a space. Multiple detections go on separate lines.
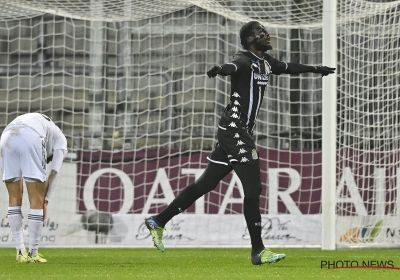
228, 51, 287, 133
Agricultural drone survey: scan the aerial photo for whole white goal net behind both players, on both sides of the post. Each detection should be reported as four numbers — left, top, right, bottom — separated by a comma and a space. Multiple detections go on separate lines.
0, 0, 400, 247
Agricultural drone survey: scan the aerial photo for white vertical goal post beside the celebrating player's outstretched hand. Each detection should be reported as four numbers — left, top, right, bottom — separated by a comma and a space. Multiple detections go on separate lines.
321, 0, 337, 250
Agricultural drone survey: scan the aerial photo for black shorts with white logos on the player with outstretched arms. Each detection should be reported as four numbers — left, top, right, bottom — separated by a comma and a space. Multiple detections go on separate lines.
207, 115, 259, 165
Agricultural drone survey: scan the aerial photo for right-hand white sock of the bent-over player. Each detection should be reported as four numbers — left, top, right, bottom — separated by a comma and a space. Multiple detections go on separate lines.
28, 209, 43, 257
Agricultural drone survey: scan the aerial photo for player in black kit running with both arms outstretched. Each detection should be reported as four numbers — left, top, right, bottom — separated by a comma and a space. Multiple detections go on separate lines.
145, 21, 335, 265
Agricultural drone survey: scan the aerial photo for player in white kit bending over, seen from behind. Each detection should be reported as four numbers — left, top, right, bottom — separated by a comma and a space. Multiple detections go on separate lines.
0, 113, 67, 263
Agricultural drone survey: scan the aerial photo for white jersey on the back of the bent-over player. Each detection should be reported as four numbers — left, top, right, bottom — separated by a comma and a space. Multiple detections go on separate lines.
4, 113, 68, 157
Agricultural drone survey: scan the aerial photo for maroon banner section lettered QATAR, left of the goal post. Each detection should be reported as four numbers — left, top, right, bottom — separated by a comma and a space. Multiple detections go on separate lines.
77, 149, 321, 214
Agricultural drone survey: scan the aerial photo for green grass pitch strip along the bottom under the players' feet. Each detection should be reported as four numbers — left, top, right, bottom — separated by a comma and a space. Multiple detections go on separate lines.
0, 248, 400, 280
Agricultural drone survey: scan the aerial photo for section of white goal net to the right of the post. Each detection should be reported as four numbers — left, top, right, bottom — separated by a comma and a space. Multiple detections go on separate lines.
336, 1, 400, 246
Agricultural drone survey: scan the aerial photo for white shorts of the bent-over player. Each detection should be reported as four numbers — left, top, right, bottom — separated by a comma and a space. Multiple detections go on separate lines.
0, 126, 47, 182
